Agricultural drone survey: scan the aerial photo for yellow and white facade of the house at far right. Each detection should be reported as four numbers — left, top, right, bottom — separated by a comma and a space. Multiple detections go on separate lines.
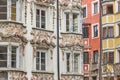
102, 0, 120, 80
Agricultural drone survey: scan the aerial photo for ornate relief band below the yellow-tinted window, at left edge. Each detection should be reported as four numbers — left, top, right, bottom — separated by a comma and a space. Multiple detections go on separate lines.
0, 22, 28, 55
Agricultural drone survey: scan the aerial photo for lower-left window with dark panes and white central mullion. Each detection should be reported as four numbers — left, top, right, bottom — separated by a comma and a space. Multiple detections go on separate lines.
0, 45, 20, 68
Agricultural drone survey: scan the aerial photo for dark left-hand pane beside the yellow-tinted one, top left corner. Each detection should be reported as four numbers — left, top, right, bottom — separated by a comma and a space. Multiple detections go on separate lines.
0, 0, 7, 20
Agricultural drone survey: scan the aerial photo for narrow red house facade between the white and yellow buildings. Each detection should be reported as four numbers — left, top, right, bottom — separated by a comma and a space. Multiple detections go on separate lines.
82, 0, 100, 80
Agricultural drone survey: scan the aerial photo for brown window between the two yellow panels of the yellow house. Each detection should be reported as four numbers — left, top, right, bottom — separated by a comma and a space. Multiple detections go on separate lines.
103, 26, 114, 38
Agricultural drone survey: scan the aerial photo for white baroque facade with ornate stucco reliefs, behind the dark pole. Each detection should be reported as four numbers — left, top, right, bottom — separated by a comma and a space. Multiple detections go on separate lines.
0, 0, 83, 80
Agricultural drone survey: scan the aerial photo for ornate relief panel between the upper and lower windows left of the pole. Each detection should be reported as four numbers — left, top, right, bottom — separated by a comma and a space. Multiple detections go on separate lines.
30, 30, 56, 56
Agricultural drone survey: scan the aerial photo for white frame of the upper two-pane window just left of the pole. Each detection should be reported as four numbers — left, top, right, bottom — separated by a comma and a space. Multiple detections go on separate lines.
35, 6, 47, 29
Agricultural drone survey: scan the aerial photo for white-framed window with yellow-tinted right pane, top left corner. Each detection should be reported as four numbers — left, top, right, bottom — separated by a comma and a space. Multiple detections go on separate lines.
0, 0, 22, 21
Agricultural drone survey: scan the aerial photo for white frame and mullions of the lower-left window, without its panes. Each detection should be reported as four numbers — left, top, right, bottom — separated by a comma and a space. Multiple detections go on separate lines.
0, 42, 22, 69
